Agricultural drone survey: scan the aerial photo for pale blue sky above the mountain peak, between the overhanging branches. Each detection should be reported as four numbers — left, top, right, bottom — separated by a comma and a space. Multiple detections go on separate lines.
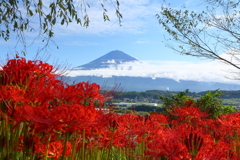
0, 0, 202, 67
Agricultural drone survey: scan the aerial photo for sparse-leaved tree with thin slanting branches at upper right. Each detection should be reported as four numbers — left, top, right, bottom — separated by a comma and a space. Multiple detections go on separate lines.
157, 0, 240, 69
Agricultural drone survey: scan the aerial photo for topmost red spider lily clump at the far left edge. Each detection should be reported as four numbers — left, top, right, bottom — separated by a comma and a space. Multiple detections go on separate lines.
0, 58, 60, 109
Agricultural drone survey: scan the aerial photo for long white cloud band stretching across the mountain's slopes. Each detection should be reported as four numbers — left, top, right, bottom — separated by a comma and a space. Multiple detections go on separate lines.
65, 54, 240, 84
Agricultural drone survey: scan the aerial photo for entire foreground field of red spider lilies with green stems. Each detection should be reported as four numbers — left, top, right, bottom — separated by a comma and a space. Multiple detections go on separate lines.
0, 57, 240, 160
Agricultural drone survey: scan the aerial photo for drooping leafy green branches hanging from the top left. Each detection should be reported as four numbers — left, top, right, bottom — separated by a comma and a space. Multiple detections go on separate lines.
0, 0, 122, 54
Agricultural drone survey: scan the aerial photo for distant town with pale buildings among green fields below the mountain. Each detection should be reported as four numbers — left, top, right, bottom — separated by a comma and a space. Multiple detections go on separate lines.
103, 90, 240, 115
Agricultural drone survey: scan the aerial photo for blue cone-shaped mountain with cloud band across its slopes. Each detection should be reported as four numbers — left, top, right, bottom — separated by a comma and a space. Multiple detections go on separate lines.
66, 50, 240, 92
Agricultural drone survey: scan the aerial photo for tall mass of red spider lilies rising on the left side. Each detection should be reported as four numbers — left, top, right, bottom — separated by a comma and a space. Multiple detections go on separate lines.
0, 58, 108, 157
